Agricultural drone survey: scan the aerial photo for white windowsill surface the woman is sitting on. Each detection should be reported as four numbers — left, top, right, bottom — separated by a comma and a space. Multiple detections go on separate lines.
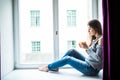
2, 69, 102, 80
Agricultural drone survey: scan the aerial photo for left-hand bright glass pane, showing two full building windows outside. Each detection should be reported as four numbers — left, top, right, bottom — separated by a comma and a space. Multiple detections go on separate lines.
18, 0, 54, 64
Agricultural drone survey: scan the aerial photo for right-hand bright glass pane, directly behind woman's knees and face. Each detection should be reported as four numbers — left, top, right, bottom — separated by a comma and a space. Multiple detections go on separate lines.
59, 0, 92, 57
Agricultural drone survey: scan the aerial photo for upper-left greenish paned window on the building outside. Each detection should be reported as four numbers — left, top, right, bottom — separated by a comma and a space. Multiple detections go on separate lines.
30, 10, 40, 26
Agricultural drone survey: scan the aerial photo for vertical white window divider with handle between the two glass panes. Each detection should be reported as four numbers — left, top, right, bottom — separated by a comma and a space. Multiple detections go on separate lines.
53, 0, 59, 60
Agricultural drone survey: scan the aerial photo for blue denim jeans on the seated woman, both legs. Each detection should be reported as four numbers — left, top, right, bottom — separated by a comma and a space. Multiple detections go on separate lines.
48, 49, 99, 76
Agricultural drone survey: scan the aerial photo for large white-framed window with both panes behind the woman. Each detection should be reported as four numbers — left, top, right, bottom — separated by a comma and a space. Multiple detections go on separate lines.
14, 0, 101, 68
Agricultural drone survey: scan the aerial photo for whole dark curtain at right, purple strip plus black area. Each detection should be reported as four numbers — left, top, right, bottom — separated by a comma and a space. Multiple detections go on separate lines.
102, 0, 120, 80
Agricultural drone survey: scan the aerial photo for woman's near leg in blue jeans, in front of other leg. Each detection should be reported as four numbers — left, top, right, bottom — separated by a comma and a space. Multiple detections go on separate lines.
48, 56, 97, 75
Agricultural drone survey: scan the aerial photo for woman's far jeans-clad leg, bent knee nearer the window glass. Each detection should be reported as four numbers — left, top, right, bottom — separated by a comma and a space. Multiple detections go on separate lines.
62, 49, 85, 61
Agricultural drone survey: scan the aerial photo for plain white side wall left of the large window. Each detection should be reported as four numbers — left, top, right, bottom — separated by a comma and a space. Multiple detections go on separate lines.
0, 0, 14, 77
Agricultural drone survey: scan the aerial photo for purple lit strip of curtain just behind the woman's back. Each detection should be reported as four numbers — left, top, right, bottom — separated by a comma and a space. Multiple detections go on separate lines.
102, 0, 110, 80
